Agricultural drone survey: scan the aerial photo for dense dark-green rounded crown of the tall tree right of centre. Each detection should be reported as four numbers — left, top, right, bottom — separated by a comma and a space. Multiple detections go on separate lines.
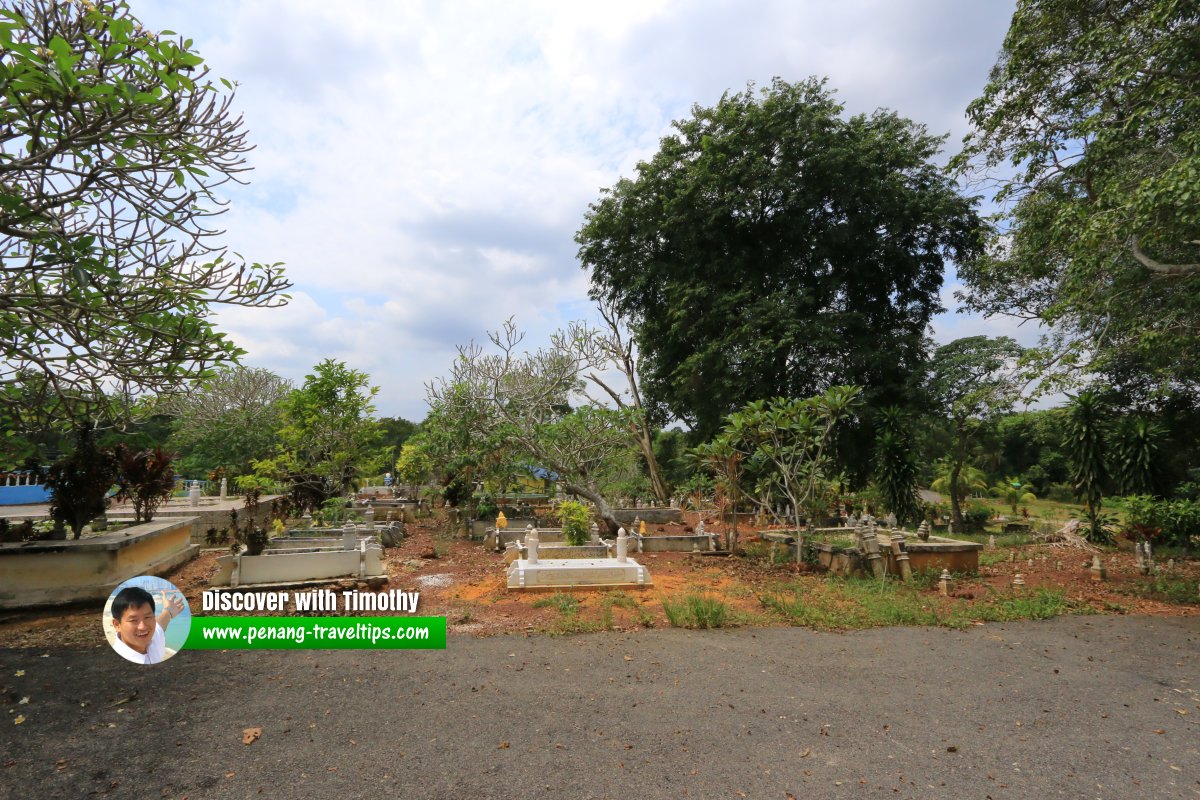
576, 79, 980, 439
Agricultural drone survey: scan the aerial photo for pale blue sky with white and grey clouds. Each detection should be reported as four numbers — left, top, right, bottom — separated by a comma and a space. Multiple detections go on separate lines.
131, 0, 1037, 421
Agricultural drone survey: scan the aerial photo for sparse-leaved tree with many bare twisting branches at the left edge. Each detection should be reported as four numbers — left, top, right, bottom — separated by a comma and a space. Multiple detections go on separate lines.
0, 0, 288, 425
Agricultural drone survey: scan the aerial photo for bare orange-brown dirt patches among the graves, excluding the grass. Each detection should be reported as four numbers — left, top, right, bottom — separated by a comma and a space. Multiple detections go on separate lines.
0, 513, 1200, 646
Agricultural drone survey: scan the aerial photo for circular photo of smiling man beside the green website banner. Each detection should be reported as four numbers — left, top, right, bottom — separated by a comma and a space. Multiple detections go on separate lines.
103, 575, 192, 664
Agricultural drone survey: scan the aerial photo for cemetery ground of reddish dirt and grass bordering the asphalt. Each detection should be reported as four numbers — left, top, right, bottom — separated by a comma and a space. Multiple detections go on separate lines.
0, 512, 1200, 648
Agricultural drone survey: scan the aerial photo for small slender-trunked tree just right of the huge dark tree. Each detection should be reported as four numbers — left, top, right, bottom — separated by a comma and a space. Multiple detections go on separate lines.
928, 336, 1024, 531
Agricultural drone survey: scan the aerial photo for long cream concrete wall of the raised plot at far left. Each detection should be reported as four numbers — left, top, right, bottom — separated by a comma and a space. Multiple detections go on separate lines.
0, 517, 199, 608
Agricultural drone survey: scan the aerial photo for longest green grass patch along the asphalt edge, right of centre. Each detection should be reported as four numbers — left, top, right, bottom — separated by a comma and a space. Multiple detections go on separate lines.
760, 577, 1084, 631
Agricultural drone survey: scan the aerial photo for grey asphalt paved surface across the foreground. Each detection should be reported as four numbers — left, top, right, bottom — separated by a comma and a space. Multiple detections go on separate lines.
0, 616, 1200, 800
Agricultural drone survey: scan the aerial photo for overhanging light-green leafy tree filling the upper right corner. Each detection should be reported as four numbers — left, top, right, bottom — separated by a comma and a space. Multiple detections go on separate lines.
956, 0, 1200, 392
